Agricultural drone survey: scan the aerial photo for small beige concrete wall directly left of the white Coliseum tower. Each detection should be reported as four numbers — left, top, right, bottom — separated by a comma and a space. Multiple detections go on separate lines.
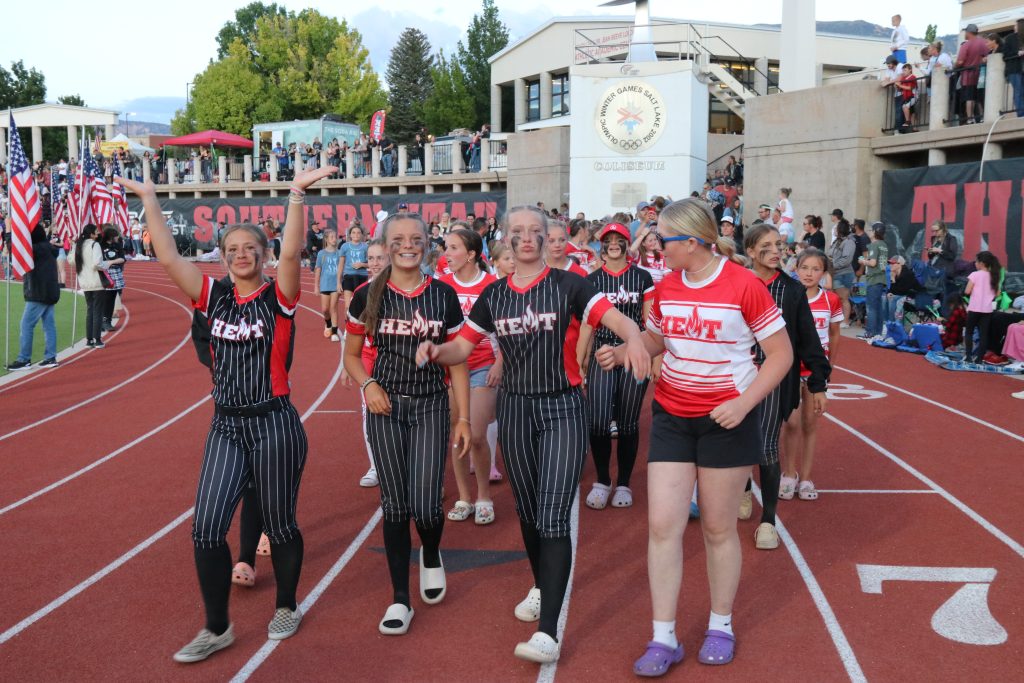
508, 126, 569, 209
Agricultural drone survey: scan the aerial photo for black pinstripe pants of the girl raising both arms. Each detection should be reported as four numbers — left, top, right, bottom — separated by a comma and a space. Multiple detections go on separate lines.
193, 403, 308, 549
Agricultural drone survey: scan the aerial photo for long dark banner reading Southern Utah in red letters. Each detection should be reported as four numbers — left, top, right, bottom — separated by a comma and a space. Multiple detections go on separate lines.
128, 193, 505, 249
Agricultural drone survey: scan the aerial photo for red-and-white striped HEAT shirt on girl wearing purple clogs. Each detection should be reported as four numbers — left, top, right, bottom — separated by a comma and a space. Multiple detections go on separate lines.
647, 259, 785, 418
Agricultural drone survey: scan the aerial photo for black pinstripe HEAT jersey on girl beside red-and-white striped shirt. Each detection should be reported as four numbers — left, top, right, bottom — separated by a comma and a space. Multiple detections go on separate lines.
462, 268, 611, 395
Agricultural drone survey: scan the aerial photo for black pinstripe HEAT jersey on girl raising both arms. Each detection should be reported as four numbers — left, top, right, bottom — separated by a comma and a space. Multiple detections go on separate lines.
195, 276, 299, 408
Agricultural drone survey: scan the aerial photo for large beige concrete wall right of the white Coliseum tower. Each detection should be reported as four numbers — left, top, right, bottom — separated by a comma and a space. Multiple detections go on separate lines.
743, 81, 896, 222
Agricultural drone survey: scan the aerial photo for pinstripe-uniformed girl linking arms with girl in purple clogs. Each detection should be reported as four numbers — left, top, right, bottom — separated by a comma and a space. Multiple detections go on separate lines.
417, 207, 650, 663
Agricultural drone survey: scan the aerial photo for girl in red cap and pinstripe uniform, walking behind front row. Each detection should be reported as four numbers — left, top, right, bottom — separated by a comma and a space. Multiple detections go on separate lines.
582, 223, 654, 510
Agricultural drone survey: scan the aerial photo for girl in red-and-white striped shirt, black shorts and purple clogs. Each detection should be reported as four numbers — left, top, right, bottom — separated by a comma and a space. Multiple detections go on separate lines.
595, 199, 793, 676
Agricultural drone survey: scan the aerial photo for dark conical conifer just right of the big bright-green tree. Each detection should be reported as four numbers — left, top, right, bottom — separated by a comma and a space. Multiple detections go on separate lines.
387, 28, 433, 143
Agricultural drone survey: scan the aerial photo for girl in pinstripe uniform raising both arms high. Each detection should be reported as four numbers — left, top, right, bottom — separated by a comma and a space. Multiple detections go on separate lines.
118, 167, 337, 663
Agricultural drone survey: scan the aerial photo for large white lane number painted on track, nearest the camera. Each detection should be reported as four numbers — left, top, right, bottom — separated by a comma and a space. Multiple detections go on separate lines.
857, 564, 1007, 645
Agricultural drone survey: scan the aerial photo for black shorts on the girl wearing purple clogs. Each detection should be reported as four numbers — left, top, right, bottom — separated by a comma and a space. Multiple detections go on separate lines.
647, 400, 763, 468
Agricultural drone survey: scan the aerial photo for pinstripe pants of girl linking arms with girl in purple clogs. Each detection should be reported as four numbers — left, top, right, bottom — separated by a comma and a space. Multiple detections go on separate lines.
498, 387, 587, 539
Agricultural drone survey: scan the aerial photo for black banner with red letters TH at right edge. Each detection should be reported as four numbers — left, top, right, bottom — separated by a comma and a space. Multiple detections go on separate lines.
882, 159, 1024, 289
